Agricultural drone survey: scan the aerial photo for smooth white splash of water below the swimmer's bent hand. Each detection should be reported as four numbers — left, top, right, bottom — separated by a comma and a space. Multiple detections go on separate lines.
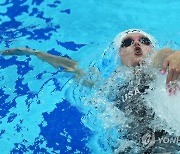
145, 73, 180, 136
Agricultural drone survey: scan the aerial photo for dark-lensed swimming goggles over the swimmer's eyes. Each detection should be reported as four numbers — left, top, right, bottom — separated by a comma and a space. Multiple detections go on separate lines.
121, 36, 152, 48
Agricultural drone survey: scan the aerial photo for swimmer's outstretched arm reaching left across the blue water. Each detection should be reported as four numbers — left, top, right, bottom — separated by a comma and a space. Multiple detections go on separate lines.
0, 48, 95, 88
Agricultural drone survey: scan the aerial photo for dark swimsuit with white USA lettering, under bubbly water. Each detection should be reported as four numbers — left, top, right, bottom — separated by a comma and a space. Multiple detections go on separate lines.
111, 72, 180, 153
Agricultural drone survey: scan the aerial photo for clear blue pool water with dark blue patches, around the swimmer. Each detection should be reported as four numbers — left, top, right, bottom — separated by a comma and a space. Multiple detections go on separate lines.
0, 0, 180, 154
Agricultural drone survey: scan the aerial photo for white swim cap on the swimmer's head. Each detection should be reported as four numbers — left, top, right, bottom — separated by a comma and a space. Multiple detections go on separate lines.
113, 29, 156, 50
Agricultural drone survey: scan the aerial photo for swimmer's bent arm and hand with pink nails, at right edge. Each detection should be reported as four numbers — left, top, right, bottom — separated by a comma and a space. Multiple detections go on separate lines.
153, 48, 180, 84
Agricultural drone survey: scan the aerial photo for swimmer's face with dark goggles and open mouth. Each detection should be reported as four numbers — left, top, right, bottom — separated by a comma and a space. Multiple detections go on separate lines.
119, 33, 153, 66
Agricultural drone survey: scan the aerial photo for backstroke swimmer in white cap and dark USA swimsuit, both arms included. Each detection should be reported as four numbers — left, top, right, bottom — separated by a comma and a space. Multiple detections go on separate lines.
1, 29, 180, 153
